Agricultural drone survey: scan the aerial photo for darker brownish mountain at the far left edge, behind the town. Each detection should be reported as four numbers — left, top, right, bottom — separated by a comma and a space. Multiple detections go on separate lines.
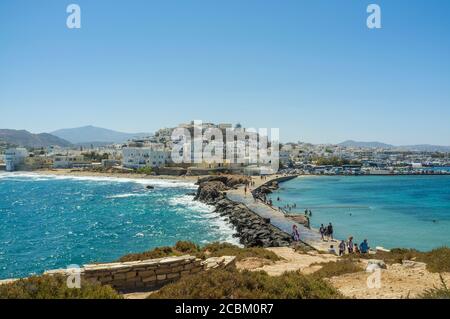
0, 129, 71, 147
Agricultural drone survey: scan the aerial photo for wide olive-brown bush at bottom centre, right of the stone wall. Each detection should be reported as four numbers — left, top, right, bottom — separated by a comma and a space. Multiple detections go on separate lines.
149, 268, 342, 299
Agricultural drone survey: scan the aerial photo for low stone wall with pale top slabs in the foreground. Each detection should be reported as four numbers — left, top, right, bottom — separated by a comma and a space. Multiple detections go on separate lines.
45, 255, 235, 291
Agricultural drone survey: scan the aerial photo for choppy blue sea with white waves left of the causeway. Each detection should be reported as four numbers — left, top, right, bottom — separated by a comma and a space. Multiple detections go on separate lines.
0, 173, 235, 279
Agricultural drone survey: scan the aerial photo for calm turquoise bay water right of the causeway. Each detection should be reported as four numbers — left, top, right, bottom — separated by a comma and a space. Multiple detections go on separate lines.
271, 176, 450, 250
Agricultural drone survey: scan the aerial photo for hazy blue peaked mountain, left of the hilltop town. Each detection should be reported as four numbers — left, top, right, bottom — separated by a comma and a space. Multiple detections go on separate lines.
51, 125, 150, 144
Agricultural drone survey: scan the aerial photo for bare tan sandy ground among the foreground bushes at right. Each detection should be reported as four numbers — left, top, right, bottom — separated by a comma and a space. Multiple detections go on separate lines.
236, 247, 450, 299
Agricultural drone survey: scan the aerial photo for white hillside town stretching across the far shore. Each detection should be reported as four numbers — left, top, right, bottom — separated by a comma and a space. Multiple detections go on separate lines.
0, 122, 450, 176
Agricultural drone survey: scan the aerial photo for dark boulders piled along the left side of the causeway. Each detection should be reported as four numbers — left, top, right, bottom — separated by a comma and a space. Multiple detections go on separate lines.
195, 176, 292, 247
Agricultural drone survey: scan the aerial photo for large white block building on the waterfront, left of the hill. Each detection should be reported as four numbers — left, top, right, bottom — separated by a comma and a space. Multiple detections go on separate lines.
122, 144, 167, 169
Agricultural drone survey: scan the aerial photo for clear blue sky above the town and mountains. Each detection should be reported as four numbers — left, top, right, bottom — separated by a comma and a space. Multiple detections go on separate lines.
0, 0, 450, 145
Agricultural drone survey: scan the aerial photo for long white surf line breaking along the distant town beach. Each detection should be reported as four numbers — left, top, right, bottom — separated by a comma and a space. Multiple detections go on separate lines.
0, 172, 197, 189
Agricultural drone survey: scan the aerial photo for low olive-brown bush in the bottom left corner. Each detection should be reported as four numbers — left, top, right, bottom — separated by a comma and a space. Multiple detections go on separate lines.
0, 275, 122, 299
